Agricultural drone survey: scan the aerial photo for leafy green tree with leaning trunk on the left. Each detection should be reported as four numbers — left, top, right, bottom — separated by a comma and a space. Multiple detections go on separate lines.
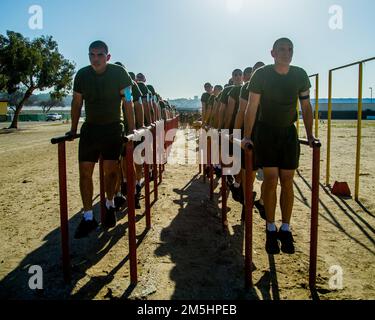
0, 31, 75, 128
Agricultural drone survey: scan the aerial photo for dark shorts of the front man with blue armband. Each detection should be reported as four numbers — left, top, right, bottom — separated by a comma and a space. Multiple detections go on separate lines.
78, 122, 124, 162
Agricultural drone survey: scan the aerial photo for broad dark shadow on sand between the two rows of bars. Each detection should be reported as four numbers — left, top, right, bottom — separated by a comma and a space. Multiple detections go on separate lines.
151, 175, 259, 300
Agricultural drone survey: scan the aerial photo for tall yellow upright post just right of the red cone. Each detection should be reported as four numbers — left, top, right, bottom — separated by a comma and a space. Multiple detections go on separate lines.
354, 63, 363, 201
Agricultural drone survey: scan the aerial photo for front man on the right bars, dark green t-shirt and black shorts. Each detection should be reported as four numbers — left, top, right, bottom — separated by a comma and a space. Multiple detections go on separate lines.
244, 38, 315, 254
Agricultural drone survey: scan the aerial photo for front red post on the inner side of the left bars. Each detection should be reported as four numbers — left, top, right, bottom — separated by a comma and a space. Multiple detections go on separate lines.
126, 141, 138, 284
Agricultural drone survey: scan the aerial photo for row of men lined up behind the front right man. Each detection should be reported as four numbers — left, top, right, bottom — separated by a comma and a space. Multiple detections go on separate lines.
201, 62, 266, 221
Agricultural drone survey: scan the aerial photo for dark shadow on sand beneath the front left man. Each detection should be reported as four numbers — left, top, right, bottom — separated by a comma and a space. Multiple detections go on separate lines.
0, 198, 146, 300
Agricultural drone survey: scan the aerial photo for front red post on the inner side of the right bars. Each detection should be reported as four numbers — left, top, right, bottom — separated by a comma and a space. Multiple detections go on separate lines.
245, 148, 253, 288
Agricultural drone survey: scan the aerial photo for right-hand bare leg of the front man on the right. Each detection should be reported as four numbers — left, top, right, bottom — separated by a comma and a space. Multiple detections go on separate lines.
280, 170, 295, 224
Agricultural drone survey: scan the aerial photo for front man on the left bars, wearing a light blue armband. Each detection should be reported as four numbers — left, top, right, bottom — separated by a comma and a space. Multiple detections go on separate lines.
68, 41, 135, 239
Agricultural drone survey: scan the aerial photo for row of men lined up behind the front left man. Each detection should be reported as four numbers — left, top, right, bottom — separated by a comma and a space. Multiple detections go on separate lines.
114, 62, 176, 215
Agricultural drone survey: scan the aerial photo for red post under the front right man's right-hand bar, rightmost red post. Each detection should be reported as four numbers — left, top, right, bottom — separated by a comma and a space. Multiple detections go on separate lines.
309, 145, 320, 289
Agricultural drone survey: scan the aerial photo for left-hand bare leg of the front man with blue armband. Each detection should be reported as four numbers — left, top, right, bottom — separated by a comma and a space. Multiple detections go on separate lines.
79, 162, 95, 211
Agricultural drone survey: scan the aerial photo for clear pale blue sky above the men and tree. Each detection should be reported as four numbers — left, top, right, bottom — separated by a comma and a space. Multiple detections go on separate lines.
0, 0, 375, 98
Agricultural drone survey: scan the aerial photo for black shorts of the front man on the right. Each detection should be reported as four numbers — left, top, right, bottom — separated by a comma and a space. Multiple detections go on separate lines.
254, 122, 300, 170
